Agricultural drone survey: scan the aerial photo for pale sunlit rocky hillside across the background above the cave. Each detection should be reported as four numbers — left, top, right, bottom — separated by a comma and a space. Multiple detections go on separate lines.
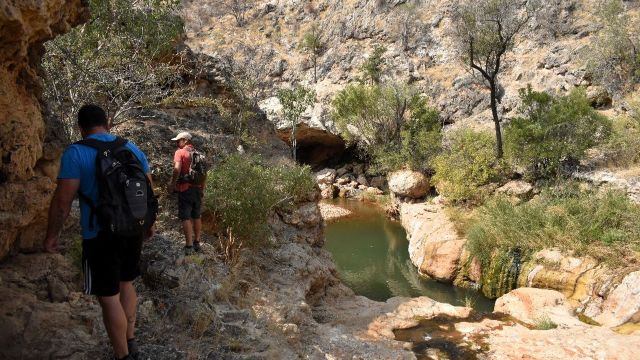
187, 0, 606, 143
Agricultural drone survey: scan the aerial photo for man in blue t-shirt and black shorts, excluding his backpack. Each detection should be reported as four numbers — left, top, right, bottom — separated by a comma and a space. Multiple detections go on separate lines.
44, 105, 153, 359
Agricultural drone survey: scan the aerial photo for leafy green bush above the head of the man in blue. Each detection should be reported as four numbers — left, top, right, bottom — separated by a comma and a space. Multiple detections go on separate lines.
43, 0, 183, 137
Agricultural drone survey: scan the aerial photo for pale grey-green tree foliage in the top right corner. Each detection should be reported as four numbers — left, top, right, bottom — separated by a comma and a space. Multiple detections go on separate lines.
585, 0, 640, 93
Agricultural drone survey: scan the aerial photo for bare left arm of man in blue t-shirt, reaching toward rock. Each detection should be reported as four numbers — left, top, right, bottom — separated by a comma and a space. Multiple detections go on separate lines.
44, 179, 80, 253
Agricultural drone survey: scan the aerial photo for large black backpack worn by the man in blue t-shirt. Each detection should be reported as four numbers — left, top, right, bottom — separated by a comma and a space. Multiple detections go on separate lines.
76, 137, 158, 237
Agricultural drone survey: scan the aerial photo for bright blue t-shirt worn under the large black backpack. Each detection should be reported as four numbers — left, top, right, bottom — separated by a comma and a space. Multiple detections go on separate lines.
58, 133, 150, 239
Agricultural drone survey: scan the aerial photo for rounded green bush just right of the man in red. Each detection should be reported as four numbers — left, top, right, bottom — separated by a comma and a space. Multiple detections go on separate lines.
204, 155, 315, 246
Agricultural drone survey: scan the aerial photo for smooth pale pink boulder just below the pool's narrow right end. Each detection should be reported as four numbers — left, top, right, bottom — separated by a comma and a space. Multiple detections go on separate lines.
494, 288, 586, 327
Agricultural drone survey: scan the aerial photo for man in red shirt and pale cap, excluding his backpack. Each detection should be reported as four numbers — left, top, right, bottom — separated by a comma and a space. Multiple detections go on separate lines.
169, 131, 204, 255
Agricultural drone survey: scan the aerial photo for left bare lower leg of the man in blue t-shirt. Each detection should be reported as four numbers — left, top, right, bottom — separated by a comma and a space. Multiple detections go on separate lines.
98, 294, 129, 358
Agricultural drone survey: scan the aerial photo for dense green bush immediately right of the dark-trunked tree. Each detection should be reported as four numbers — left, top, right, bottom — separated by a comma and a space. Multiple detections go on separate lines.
505, 86, 611, 178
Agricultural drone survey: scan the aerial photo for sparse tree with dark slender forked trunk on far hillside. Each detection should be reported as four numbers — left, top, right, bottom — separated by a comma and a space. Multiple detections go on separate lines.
453, 0, 534, 158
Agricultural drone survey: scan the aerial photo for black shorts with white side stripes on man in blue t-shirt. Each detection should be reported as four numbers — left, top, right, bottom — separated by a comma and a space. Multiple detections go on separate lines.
82, 232, 142, 296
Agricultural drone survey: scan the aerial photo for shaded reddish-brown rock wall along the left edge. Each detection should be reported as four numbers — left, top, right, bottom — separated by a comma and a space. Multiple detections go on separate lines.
0, 0, 89, 258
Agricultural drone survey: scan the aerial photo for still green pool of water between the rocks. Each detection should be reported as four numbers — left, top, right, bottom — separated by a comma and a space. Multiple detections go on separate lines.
325, 199, 494, 312
